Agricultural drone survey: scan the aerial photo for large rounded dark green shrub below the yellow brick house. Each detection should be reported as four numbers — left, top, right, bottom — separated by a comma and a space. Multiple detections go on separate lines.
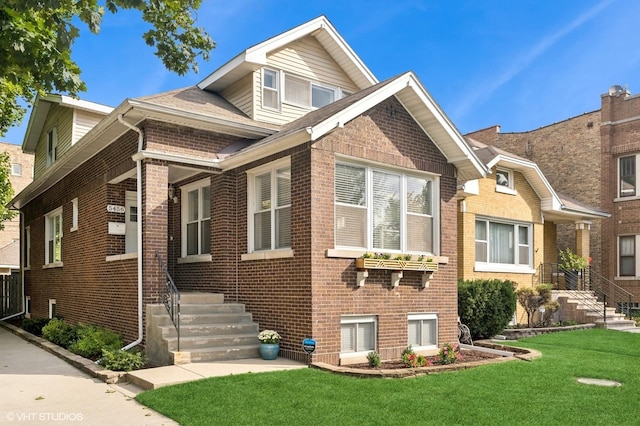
458, 280, 516, 340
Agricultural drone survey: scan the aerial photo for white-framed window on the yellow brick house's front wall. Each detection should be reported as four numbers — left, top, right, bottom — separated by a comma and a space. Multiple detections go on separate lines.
475, 218, 533, 270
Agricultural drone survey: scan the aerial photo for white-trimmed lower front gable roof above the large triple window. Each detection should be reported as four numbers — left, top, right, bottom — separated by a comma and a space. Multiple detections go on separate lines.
221, 72, 486, 181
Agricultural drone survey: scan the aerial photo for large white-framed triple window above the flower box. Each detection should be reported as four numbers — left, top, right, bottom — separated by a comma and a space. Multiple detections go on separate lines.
335, 162, 439, 253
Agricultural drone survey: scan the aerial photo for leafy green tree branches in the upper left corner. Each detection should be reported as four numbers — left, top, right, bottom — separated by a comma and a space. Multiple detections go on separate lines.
0, 0, 215, 136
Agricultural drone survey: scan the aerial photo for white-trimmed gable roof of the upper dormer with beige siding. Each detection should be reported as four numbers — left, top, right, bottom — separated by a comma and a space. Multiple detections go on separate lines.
198, 15, 378, 92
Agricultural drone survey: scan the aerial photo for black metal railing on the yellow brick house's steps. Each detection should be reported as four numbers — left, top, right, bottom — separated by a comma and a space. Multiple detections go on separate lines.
539, 263, 633, 322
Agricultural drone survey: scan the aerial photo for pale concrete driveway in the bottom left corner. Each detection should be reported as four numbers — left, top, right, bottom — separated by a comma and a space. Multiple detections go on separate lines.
0, 327, 177, 425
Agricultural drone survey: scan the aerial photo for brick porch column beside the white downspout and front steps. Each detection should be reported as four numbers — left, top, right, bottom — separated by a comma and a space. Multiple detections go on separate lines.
139, 159, 169, 304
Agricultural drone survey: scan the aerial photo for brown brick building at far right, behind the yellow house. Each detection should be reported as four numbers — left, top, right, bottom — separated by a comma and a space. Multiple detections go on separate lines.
467, 86, 640, 309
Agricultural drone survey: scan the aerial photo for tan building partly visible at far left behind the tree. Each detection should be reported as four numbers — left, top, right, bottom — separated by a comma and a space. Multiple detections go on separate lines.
0, 142, 33, 275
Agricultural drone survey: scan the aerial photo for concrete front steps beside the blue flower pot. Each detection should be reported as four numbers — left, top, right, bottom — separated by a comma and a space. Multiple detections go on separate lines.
146, 292, 260, 365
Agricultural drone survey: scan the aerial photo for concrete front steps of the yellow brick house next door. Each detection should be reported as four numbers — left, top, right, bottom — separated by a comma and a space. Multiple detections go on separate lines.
553, 290, 635, 329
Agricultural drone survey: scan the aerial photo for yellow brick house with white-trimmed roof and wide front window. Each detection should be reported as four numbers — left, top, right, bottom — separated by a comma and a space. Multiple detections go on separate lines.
458, 137, 610, 324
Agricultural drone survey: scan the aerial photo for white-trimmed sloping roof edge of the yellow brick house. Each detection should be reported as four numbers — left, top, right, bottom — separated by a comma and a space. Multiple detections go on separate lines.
467, 138, 611, 223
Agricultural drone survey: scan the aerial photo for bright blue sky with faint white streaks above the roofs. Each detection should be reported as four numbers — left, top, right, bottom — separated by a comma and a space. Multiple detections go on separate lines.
3, 0, 640, 144
